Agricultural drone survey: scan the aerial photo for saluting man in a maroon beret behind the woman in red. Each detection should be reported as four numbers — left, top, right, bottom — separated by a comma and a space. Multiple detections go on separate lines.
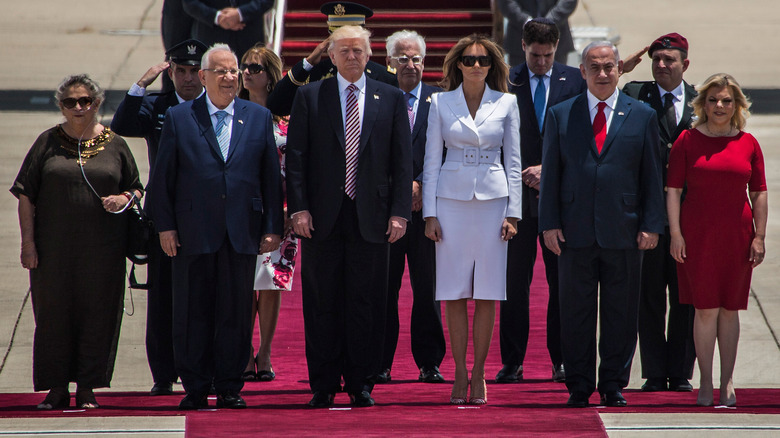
623, 33, 696, 392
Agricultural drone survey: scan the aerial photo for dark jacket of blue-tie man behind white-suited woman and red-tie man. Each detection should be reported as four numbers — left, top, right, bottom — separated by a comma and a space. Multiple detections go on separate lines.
509, 62, 587, 217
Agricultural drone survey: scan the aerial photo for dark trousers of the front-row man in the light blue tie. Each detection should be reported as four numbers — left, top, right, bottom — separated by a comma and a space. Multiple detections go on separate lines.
173, 235, 257, 396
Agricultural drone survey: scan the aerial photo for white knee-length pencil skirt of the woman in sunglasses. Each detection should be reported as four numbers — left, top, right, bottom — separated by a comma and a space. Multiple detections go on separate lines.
436, 197, 507, 301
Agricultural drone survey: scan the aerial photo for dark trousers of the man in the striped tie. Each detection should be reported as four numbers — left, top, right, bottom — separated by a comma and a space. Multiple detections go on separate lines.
301, 196, 390, 393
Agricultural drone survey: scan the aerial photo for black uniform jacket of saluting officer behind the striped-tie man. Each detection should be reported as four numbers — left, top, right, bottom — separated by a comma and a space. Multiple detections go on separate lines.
266, 58, 398, 116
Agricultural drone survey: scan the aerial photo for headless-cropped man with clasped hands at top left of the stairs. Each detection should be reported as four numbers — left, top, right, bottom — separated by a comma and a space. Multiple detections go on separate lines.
182, 0, 274, 59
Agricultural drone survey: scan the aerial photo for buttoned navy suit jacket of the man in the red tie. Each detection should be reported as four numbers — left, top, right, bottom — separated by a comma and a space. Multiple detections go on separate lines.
539, 93, 666, 249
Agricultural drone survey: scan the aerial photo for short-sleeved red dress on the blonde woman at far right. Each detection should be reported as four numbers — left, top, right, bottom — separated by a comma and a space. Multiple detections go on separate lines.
667, 129, 766, 310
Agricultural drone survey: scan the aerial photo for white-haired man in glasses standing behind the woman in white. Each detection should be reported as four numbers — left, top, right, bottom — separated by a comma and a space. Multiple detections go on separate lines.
376, 30, 447, 383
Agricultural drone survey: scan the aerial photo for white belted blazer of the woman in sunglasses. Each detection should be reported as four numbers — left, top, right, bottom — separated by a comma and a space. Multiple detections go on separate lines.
423, 84, 523, 219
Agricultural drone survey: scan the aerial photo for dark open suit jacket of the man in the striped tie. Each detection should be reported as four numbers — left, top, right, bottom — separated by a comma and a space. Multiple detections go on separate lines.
286, 77, 412, 243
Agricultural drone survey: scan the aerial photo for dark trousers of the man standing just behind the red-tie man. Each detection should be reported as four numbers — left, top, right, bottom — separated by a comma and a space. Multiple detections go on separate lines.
499, 217, 563, 366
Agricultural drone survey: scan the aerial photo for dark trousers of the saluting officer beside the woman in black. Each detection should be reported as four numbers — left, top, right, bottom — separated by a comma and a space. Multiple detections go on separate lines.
146, 236, 179, 383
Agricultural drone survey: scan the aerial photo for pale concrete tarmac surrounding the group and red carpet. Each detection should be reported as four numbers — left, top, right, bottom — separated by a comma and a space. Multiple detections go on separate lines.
0, 0, 780, 437
